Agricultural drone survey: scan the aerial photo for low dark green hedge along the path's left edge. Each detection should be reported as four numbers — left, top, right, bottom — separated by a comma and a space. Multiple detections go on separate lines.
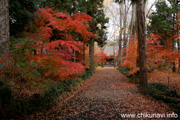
0, 69, 92, 119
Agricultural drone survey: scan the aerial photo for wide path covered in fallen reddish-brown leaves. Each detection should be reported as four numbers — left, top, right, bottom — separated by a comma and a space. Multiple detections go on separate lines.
28, 67, 170, 119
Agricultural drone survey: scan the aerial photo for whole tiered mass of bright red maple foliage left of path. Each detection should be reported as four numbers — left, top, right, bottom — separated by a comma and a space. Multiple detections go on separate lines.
24, 7, 96, 80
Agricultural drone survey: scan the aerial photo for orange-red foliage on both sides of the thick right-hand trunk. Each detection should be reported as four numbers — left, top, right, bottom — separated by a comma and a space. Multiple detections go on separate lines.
121, 34, 180, 74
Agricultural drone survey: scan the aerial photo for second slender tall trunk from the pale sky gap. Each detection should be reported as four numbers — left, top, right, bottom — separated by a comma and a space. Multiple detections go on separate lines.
123, 0, 127, 56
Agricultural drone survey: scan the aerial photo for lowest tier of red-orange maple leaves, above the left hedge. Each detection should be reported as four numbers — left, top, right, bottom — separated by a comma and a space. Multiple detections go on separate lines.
37, 56, 85, 81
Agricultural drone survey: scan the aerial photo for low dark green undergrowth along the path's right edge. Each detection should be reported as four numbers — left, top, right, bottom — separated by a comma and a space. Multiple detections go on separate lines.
119, 67, 180, 113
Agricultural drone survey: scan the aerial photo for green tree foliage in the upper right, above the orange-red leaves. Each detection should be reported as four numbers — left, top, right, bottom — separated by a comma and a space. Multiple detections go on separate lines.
147, 0, 178, 45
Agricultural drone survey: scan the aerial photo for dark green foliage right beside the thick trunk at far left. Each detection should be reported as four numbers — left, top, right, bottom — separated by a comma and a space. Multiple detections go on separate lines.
9, 0, 39, 36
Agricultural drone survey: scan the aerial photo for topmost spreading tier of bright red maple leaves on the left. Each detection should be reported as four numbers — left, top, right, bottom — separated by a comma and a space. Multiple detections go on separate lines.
35, 7, 95, 41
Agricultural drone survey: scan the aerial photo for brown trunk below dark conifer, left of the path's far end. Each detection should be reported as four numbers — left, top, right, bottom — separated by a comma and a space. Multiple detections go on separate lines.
89, 38, 94, 73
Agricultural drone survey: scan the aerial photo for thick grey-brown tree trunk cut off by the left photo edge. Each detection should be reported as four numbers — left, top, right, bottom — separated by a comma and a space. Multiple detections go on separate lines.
0, 0, 10, 57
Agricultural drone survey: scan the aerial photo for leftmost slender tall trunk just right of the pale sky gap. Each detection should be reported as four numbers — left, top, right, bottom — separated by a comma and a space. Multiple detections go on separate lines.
118, 4, 122, 69
